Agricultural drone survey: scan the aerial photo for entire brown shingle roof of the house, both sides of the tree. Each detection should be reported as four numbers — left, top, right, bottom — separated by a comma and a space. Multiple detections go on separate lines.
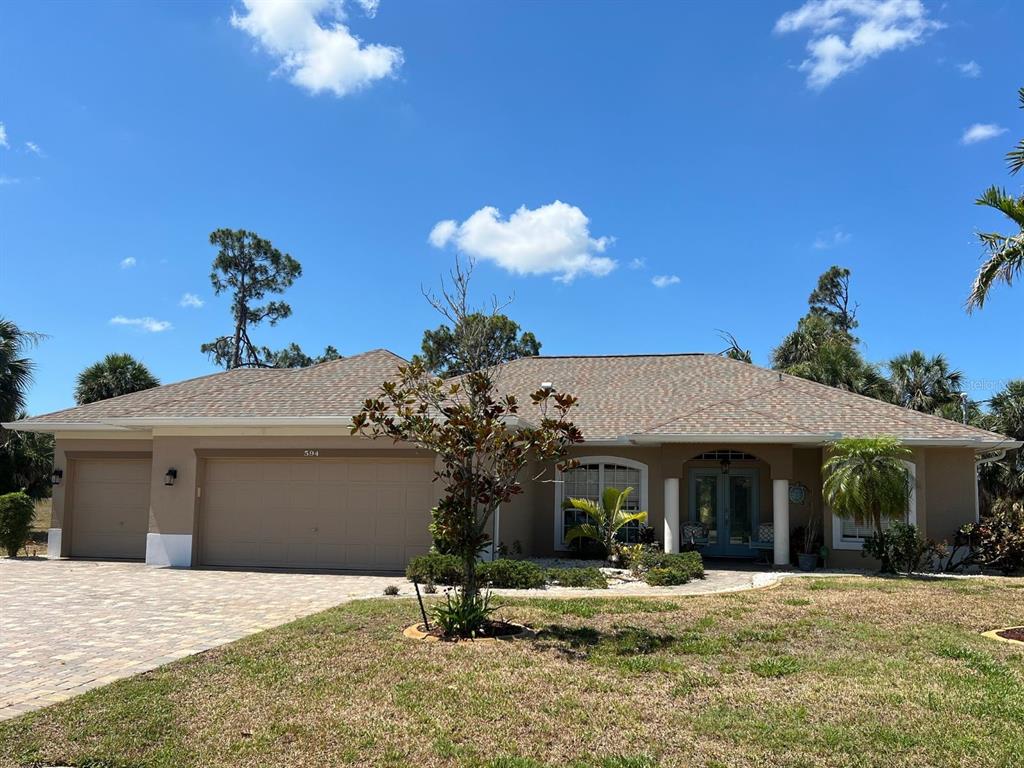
8, 349, 1010, 446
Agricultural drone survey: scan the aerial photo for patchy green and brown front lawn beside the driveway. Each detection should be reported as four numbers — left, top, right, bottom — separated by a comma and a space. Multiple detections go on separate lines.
0, 578, 1024, 768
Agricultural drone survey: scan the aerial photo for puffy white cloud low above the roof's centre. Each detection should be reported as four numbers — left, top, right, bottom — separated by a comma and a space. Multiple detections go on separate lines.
429, 200, 615, 283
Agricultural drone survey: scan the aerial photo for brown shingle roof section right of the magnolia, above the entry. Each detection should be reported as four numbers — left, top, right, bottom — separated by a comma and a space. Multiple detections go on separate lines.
485, 354, 1008, 443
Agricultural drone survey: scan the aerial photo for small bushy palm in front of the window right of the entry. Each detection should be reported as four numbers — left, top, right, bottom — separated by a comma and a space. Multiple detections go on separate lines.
822, 437, 910, 571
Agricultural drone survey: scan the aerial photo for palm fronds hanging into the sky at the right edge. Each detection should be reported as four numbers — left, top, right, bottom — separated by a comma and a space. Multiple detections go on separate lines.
967, 88, 1024, 312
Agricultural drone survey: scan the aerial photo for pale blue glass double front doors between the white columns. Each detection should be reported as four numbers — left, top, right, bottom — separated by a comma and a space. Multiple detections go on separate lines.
689, 469, 758, 557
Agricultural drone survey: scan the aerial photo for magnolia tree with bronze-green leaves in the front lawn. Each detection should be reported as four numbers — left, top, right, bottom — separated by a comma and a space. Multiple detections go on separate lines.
351, 264, 583, 618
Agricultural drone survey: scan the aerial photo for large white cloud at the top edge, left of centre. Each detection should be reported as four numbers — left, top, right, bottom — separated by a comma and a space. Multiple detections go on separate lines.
231, 0, 402, 96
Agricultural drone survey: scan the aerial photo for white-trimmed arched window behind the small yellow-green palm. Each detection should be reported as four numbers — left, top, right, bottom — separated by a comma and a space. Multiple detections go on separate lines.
555, 456, 647, 549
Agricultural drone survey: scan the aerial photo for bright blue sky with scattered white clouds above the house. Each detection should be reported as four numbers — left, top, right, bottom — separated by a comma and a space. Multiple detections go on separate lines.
0, 0, 1024, 413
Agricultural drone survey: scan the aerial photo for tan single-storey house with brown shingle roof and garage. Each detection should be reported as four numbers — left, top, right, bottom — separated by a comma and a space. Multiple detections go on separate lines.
5, 349, 1020, 570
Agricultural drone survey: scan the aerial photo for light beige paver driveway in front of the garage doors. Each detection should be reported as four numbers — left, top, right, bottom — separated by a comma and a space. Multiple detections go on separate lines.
0, 559, 410, 719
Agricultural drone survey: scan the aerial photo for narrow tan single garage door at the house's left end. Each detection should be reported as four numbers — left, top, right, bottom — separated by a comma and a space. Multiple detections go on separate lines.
71, 459, 151, 560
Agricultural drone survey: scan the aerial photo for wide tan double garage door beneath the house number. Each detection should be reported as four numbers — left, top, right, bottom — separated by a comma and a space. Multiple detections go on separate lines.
200, 458, 434, 570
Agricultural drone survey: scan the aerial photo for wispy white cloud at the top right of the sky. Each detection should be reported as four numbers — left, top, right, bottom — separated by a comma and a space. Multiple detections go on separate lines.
775, 0, 945, 90
